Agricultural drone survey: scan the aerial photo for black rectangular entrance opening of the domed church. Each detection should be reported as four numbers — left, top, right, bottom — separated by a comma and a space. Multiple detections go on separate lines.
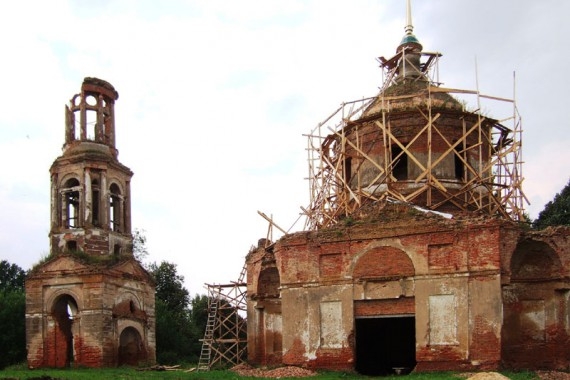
355, 316, 416, 376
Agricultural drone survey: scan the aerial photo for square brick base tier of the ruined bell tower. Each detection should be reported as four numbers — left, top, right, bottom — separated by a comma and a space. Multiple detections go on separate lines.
26, 255, 156, 368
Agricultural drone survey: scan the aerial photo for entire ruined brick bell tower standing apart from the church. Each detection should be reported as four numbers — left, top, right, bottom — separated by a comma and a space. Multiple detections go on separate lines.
26, 78, 156, 368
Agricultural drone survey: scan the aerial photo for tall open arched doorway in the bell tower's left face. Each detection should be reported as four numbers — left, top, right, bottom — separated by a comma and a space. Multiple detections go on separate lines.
52, 294, 78, 367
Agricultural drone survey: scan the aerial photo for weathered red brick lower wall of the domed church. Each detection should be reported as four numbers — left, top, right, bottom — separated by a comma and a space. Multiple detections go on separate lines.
244, 206, 570, 371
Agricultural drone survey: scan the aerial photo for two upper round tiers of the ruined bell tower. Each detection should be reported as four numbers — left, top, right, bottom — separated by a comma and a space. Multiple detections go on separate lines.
50, 78, 133, 256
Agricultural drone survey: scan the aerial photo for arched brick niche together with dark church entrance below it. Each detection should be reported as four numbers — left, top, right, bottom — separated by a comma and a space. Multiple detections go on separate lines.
352, 246, 416, 376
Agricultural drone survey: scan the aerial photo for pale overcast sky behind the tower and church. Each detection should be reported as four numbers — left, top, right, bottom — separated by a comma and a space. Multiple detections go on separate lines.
0, 0, 570, 295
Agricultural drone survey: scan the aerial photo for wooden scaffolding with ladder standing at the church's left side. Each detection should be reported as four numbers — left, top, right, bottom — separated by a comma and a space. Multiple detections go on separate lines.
197, 265, 247, 371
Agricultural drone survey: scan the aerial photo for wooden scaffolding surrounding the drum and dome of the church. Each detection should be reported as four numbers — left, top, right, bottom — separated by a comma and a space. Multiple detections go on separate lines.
302, 48, 528, 230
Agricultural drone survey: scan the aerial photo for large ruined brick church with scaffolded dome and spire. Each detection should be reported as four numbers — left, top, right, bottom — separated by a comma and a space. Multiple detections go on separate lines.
246, 2, 570, 375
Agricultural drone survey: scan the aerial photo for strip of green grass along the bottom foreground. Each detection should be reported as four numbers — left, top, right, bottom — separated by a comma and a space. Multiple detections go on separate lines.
0, 365, 538, 380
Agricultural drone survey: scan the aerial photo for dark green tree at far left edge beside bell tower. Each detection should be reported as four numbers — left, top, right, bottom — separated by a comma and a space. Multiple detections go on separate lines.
0, 260, 26, 369
